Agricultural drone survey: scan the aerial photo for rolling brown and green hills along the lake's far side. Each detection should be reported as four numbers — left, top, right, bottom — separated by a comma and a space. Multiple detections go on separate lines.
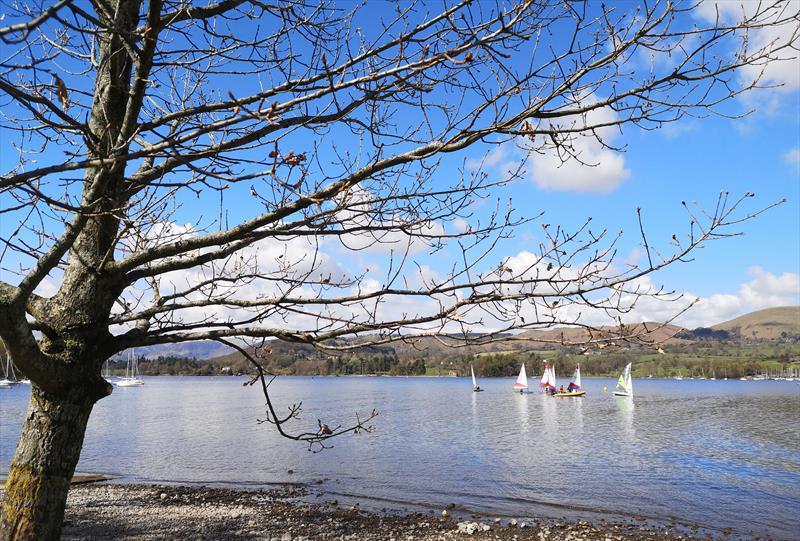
119, 306, 800, 374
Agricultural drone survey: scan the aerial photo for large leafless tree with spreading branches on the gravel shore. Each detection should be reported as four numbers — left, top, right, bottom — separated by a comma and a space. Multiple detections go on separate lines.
0, 0, 798, 539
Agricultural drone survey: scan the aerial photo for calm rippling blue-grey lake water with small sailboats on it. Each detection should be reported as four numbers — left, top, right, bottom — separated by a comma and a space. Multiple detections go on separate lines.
0, 377, 800, 538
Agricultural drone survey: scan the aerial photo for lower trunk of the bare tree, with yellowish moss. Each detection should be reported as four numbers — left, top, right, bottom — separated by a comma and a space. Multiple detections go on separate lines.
0, 384, 96, 541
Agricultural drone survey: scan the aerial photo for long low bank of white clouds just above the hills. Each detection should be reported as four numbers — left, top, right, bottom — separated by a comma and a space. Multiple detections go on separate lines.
111, 217, 800, 340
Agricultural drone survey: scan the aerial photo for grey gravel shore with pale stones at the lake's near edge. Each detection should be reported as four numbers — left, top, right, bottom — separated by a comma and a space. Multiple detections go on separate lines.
12, 484, 736, 541
